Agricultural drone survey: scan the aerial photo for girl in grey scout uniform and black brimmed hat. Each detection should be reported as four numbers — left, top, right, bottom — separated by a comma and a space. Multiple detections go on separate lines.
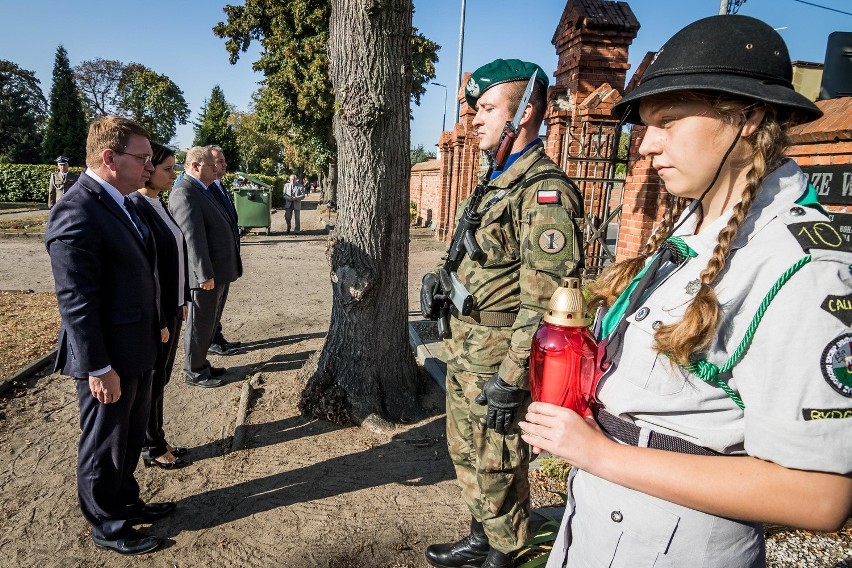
520, 16, 852, 568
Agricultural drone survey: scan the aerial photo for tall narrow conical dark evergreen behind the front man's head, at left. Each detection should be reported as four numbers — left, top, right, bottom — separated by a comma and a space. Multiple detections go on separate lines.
41, 45, 88, 165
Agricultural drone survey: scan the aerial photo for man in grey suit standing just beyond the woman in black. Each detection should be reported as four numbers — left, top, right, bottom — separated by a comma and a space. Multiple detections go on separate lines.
169, 146, 243, 387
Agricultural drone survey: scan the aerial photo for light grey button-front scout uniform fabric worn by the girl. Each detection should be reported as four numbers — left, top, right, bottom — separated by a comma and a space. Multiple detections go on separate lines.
547, 161, 852, 568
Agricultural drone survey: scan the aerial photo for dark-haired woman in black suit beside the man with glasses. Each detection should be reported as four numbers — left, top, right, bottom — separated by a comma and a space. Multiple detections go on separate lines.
130, 142, 189, 469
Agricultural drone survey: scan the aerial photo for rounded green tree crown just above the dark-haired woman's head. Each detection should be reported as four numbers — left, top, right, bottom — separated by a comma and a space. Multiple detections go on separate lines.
116, 63, 189, 144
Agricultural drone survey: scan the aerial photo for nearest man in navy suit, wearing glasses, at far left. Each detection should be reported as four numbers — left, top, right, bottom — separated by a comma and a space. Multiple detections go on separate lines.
45, 116, 175, 554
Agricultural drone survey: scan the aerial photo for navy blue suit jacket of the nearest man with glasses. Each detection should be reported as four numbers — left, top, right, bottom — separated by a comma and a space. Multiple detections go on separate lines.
45, 173, 161, 379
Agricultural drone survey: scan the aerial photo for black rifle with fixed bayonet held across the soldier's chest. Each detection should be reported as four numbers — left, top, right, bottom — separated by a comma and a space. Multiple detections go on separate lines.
435, 73, 535, 338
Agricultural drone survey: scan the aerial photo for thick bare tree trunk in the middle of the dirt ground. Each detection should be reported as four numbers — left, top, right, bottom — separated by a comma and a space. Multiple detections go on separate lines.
300, 0, 417, 425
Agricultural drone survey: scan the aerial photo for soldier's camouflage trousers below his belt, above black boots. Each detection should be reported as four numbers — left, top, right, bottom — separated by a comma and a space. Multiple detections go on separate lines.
447, 365, 530, 553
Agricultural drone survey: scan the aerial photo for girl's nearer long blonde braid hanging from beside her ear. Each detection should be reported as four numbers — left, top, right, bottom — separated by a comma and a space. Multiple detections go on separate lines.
654, 109, 786, 365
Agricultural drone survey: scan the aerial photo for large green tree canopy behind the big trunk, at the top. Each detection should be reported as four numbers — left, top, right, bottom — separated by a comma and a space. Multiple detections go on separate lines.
213, 0, 440, 172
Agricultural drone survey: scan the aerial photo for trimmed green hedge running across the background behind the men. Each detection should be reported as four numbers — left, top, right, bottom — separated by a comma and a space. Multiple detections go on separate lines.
0, 164, 286, 207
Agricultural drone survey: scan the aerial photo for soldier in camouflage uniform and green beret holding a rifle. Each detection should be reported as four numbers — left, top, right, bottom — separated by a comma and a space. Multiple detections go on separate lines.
421, 59, 582, 568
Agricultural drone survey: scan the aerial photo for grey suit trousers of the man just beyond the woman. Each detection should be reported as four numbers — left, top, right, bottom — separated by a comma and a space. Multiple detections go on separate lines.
183, 284, 226, 381
